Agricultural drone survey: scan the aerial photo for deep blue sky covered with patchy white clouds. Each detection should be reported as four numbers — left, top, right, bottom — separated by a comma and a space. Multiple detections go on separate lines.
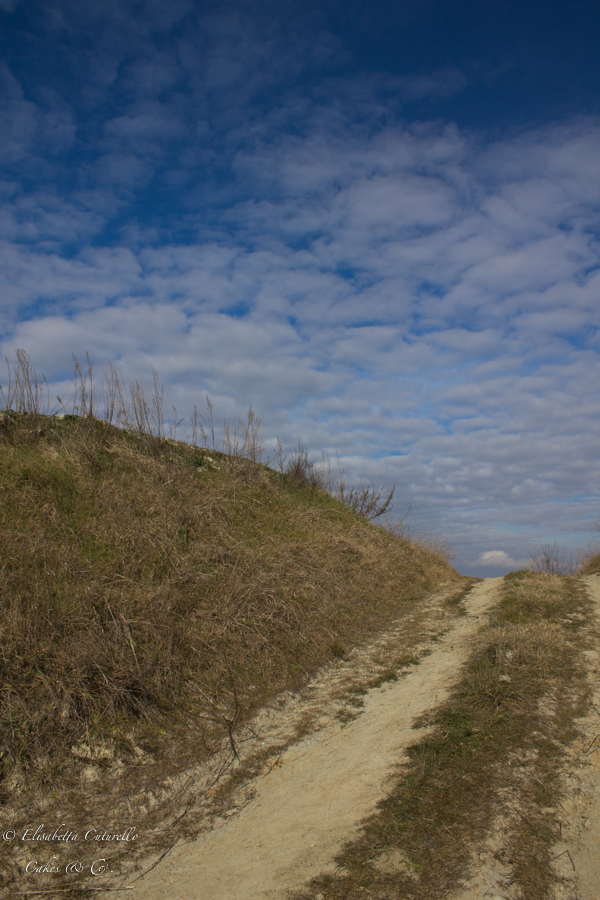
0, 0, 600, 576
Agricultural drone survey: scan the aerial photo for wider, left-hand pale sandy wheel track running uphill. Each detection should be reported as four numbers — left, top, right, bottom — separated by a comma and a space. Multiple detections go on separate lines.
135, 578, 501, 900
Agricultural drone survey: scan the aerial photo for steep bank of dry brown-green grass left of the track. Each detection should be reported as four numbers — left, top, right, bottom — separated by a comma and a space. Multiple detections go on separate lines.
0, 412, 459, 783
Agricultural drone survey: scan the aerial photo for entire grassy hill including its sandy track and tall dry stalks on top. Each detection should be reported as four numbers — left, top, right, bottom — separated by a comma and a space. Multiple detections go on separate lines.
0, 362, 600, 900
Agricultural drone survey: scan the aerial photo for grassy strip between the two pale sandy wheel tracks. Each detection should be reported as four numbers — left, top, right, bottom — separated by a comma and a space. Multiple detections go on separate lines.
294, 571, 592, 900
